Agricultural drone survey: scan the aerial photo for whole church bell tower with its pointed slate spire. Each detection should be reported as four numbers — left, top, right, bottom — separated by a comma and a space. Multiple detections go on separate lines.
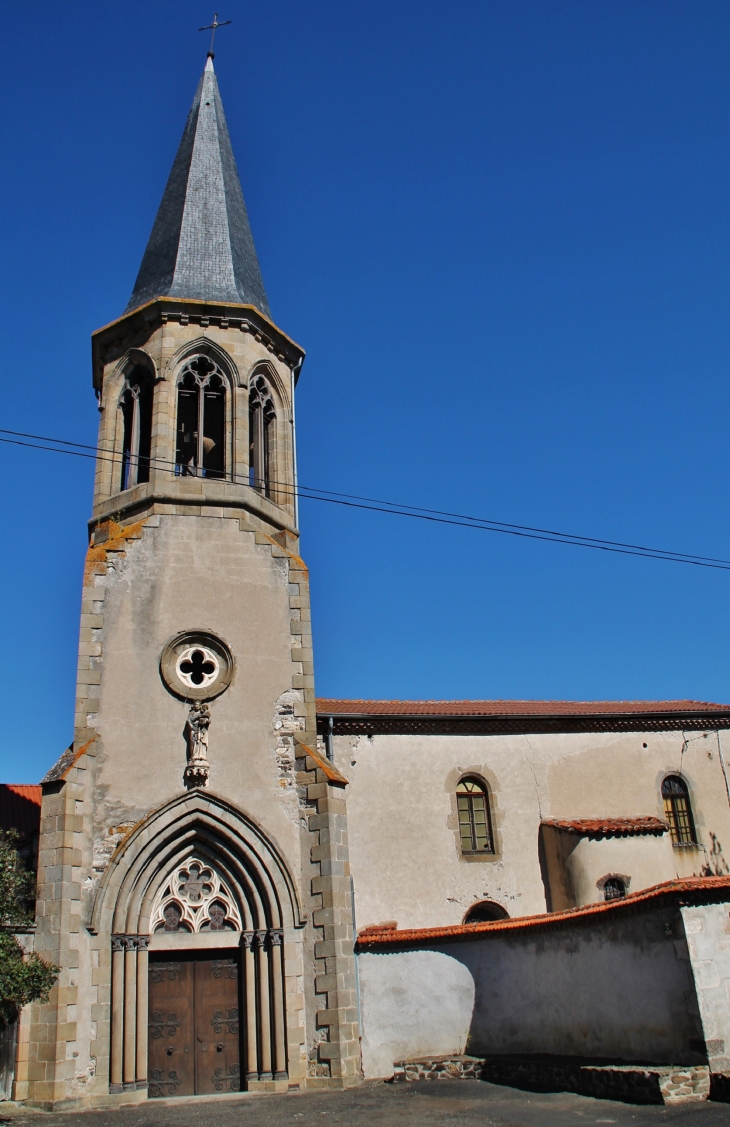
27, 55, 360, 1107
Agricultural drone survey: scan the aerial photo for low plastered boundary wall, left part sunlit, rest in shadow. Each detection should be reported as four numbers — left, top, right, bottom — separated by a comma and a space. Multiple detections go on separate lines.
358, 906, 707, 1077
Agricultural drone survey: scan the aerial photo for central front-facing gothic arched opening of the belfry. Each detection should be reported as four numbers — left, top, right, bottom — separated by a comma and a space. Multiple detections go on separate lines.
175, 356, 225, 478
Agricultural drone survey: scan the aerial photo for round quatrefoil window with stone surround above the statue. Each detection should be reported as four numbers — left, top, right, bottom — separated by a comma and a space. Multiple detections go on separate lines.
160, 630, 233, 701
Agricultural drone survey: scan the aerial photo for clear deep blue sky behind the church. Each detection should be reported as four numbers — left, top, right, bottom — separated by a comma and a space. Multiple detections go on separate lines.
0, 0, 730, 782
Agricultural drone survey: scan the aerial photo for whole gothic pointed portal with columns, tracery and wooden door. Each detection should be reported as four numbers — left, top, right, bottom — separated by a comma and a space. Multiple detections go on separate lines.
92, 791, 303, 1095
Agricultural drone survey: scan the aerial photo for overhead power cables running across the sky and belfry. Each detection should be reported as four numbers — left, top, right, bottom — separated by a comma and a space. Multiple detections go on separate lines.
0, 427, 730, 571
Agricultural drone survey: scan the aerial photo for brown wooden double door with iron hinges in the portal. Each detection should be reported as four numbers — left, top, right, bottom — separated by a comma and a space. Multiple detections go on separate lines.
148, 950, 242, 1098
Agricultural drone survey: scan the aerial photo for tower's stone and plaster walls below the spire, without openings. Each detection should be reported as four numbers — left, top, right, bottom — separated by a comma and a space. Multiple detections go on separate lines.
27, 301, 359, 1107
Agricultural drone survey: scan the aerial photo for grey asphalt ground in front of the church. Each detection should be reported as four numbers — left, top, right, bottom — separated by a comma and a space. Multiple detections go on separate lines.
0, 1080, 730, 1127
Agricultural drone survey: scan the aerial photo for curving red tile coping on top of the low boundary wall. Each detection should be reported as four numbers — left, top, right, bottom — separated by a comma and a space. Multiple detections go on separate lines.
357, 876, 730, 951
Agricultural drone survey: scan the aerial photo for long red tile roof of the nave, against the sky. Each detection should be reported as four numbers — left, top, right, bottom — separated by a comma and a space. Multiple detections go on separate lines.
317, 696, 730, 717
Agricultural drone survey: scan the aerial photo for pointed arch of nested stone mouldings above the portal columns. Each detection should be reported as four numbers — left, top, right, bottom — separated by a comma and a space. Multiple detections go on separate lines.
90, 791, 305, 933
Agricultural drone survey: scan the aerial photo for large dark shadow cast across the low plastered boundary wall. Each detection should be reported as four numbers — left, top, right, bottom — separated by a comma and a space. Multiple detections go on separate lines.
443, 907, 706, 1064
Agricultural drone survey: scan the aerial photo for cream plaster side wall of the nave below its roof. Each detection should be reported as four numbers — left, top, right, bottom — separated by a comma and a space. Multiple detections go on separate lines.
331, 725, 730, 929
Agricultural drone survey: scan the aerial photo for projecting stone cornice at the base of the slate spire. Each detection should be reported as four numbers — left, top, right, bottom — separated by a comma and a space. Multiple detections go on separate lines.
91, 298, 304, 393
